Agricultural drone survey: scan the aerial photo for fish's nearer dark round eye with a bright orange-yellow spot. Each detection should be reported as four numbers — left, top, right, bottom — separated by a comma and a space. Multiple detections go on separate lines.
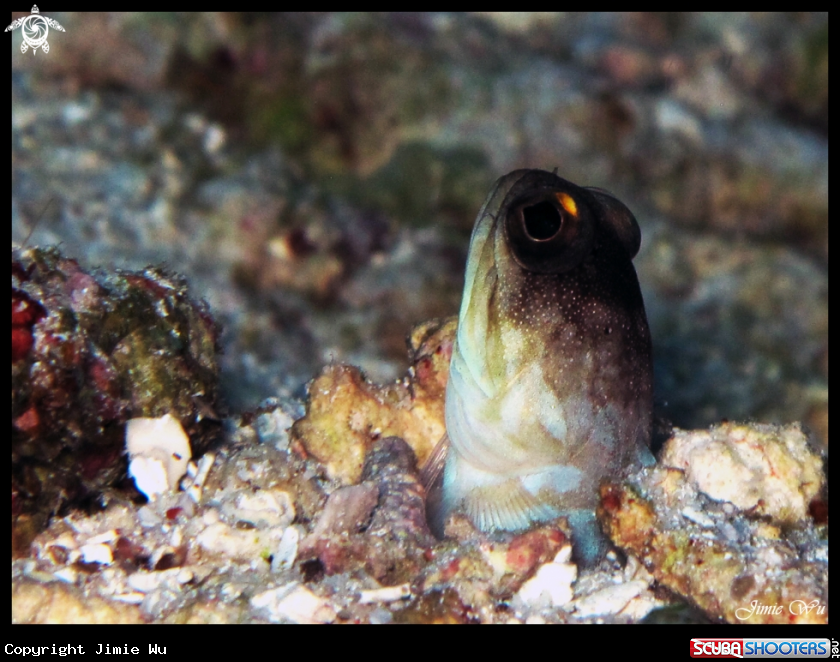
504, 189, 594, 273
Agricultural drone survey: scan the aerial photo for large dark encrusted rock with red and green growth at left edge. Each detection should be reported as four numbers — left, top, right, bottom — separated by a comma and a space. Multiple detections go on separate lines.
12, 248, 223, 552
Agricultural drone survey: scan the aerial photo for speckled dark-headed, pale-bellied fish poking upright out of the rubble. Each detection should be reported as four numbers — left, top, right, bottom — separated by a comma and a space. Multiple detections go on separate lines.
428, 170, 653, 560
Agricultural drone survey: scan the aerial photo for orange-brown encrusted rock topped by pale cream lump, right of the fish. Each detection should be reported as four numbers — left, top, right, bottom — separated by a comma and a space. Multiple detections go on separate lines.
599, 425, 828, 623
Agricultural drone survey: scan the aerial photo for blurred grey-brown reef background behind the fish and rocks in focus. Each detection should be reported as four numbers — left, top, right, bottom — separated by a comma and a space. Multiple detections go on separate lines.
9, 11, 828, 446
